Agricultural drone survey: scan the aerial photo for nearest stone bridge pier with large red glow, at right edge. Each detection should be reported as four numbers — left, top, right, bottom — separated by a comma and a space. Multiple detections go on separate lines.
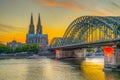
104, 47, 120, 71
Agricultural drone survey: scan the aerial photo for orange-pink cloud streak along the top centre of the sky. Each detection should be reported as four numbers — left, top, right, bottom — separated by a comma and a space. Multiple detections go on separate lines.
35, 0, 86, 11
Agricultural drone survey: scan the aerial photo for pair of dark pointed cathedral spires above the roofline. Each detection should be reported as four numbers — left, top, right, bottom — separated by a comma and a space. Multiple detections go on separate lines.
29, 14, 42, 34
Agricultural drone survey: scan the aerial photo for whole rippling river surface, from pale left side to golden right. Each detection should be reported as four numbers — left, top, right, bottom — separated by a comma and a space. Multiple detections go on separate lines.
0, 58, 120, 80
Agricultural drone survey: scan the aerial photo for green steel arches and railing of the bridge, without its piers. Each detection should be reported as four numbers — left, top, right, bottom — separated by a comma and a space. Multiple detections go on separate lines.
50, 16, 120, 48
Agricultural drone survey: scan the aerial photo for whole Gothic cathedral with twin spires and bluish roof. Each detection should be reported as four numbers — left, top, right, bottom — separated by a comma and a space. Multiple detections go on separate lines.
26, 14, 48, 48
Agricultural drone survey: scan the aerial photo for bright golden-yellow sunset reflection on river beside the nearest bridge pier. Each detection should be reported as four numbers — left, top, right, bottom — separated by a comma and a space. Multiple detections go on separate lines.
81, 59, 105, 80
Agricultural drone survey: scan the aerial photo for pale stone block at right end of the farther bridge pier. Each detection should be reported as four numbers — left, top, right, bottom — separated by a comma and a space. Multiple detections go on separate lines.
74, 48, 86, 60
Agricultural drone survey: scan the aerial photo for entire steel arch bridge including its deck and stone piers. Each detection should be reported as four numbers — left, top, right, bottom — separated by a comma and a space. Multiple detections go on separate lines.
49, 16, 120, 70
